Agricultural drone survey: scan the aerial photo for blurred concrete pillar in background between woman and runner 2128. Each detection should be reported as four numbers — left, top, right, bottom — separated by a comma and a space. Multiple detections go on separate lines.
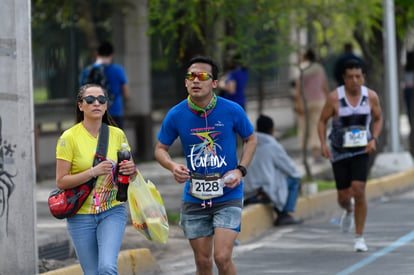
124, 0, 154, 161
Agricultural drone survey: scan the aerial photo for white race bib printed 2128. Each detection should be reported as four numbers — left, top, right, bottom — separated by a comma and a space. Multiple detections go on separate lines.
190, 173, 224, 200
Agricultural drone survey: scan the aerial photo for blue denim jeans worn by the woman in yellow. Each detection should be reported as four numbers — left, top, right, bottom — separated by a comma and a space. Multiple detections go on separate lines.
67, 204, 127, 275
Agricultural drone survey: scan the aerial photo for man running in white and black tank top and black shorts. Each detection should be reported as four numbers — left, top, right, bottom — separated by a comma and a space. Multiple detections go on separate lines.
318, 60, 383, 252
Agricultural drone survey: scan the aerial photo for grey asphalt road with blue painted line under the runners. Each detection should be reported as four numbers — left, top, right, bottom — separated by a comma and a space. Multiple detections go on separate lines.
155, 191, 414, 275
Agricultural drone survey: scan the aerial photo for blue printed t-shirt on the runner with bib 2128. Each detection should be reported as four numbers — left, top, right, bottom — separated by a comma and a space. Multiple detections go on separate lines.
158, 97, 254, 203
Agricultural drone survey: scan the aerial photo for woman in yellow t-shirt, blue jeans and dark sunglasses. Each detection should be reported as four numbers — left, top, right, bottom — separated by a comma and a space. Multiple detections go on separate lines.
56, 84, 136, 275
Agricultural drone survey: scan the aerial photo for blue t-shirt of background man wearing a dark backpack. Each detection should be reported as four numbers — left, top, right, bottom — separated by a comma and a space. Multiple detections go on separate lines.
80, 63, 128, 116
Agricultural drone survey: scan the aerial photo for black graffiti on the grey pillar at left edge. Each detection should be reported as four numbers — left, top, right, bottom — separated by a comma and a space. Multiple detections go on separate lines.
0, 117, 17, 235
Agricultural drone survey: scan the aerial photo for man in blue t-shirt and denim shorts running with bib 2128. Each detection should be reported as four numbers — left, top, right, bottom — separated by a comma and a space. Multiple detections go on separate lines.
154, 56, 257, 274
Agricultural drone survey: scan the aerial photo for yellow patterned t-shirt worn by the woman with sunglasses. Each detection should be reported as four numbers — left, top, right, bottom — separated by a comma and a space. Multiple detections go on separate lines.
56, 123, 129, 214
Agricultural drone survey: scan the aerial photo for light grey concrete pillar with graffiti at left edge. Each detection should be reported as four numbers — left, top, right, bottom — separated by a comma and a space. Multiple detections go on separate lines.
0, 0, 38, 274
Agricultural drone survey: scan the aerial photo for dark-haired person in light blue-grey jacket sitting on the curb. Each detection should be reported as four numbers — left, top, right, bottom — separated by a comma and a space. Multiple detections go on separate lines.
244, 115, 302, 226
